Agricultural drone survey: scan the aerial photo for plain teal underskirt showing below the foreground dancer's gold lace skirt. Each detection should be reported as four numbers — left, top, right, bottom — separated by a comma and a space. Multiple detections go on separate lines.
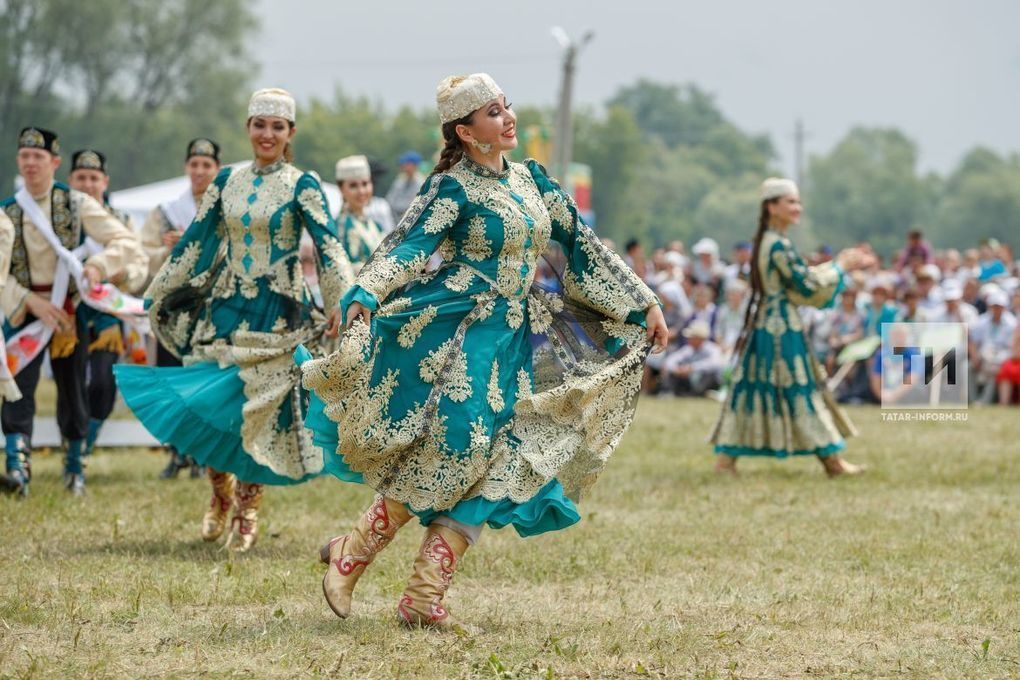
294, 347, 580, 536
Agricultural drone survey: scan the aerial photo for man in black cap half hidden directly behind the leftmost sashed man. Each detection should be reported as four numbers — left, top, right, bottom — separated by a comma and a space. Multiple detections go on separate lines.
67, 149, 145, 457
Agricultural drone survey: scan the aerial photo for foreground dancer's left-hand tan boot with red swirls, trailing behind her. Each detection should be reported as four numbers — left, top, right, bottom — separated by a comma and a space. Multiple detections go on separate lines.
319, 495, 411, 619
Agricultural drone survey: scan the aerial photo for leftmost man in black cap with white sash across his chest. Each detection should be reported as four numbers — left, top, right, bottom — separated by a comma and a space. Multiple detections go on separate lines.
0, 127, 147, 495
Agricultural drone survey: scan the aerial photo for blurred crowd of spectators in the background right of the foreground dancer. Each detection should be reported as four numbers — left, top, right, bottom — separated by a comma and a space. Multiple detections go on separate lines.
611, 230, 1020, 405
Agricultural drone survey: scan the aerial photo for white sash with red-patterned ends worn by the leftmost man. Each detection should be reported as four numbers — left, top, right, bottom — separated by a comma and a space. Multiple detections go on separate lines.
0, 187, 149, 379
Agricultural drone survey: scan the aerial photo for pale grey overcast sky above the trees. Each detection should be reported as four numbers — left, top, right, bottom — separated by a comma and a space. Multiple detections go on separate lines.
253, 0, 1020, 172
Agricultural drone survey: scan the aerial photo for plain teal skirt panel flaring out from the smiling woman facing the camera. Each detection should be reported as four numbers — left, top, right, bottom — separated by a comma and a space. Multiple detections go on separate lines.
113, 362, 316, 485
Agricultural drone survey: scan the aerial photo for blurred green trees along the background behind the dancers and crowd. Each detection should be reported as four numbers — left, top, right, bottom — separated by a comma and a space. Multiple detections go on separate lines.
0, 0, 1020, 254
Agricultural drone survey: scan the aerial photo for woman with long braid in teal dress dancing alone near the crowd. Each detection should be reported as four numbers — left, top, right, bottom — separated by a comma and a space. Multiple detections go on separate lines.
711, 177, 869, 476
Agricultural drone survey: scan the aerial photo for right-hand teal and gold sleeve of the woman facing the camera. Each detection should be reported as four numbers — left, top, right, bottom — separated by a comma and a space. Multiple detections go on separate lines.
294, 172, 354, 313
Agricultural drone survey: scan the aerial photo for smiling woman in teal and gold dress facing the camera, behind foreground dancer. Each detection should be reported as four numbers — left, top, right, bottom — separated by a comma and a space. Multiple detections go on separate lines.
116, 90, 353, 552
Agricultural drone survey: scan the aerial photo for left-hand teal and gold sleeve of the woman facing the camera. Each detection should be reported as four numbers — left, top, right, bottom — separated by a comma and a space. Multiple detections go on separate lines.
146, 167, 231, 358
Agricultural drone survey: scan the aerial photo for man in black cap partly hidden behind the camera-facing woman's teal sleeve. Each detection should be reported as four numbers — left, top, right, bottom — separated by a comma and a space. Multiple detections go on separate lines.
142, 138, 220, 479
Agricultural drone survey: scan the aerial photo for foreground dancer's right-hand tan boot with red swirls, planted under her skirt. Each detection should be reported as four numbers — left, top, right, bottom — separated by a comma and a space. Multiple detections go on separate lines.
397, 524, 468, 630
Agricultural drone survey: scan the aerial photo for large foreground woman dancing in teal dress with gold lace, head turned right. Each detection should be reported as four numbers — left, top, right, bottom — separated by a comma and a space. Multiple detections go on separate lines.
299, 73, 666, 628
